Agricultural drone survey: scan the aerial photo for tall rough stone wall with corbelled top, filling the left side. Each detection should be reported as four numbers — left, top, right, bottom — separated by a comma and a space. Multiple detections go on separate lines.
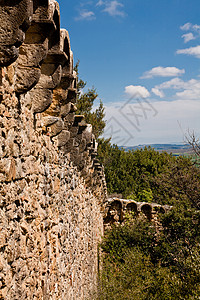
0, 0, 107, 300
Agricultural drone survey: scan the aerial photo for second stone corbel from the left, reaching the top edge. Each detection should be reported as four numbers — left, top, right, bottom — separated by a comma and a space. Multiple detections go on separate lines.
15, 0, 60, 94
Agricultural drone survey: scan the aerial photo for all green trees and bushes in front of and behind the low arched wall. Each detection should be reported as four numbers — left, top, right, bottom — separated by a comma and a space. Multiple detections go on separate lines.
97, 140, 200, 300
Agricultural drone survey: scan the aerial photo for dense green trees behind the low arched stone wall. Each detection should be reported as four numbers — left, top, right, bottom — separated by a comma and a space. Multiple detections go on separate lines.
98, 140, 200, 209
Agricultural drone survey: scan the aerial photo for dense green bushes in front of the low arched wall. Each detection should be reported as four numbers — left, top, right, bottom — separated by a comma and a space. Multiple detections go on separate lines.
98, 208, 200, 300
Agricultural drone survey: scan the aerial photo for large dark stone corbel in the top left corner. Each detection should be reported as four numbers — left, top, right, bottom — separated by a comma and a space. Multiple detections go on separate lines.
0, 0, 33, 67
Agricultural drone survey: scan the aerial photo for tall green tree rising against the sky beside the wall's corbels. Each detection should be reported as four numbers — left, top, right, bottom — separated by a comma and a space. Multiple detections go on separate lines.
74, 61, 106, 138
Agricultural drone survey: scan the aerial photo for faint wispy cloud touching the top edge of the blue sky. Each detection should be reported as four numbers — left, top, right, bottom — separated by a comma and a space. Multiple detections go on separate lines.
96, 0, 125, 17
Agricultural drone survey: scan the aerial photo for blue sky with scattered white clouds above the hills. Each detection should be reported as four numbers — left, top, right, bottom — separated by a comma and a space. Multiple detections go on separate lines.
59, 0, 200, 146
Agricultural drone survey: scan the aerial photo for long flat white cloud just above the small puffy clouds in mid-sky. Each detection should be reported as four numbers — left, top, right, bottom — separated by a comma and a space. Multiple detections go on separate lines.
141, 66, 185, 79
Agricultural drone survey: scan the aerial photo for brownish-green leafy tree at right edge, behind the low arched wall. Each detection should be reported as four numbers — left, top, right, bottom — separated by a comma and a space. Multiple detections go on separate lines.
151, 156, 200, 209
